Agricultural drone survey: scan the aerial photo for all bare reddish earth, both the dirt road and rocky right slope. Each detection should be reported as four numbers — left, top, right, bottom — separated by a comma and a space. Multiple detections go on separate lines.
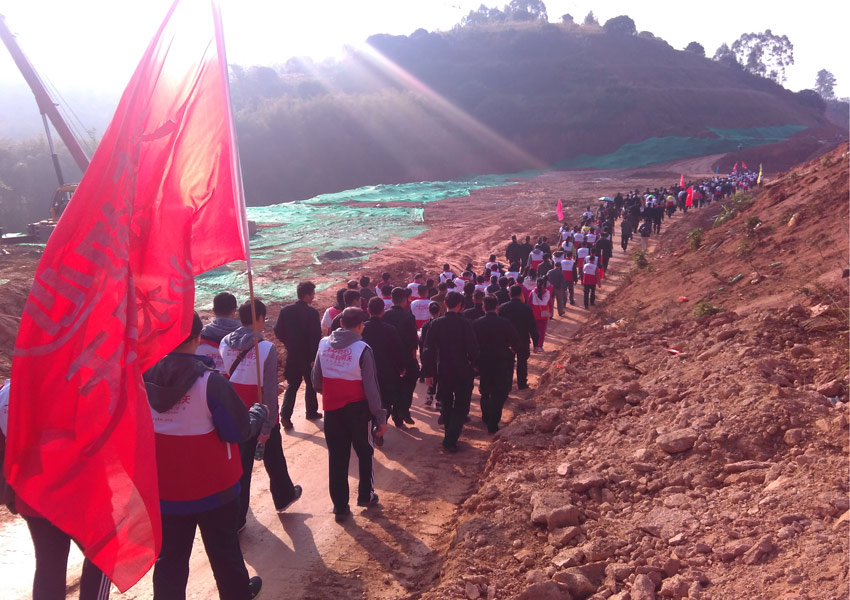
0, 146, 848, 600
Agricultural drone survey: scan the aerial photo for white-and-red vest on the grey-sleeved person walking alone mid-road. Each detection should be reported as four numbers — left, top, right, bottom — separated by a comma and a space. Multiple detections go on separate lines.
318, 338, 367, 411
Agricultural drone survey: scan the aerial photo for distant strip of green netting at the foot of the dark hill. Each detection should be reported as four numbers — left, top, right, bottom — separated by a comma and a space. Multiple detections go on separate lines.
555, 125, 806, 169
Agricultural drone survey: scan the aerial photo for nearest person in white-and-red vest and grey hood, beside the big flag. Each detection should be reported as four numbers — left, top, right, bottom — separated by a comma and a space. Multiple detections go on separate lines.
144, 313, 269, 600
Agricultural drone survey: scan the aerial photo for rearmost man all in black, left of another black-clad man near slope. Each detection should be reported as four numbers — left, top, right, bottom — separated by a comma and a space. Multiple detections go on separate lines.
422, 292, 479, 452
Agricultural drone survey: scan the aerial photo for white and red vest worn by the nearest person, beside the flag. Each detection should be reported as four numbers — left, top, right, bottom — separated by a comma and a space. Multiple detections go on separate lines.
151, 373, 242, 502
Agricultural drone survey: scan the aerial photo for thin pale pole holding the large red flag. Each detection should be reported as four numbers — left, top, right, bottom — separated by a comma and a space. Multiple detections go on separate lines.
210, 0, 262, 408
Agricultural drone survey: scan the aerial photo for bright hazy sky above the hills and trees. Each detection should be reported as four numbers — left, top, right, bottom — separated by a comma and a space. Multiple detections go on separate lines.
0, 0, 850, 118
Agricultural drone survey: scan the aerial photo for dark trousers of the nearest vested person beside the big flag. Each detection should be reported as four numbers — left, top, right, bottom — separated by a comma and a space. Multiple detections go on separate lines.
153, 500, 250, 600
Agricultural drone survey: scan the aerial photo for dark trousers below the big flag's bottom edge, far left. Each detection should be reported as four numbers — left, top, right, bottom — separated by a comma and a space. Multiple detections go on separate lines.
24, 517, 110, 600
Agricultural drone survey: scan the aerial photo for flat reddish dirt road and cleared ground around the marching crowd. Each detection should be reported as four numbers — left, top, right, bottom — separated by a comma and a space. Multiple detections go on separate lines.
0, 161, 696, 599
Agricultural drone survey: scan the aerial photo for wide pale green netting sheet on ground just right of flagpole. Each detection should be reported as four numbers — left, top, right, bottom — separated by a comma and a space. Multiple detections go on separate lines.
195, 171, 520, 308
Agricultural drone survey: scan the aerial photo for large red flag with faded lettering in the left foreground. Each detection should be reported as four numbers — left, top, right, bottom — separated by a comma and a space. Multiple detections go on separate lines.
5, 0, 247, 591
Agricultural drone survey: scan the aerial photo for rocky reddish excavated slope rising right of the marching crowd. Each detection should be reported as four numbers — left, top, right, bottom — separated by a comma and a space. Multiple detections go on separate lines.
423, 144, 850, 600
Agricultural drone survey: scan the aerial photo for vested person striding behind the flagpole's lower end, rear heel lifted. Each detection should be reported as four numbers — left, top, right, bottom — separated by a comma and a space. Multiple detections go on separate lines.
220, 300, 302, 531
